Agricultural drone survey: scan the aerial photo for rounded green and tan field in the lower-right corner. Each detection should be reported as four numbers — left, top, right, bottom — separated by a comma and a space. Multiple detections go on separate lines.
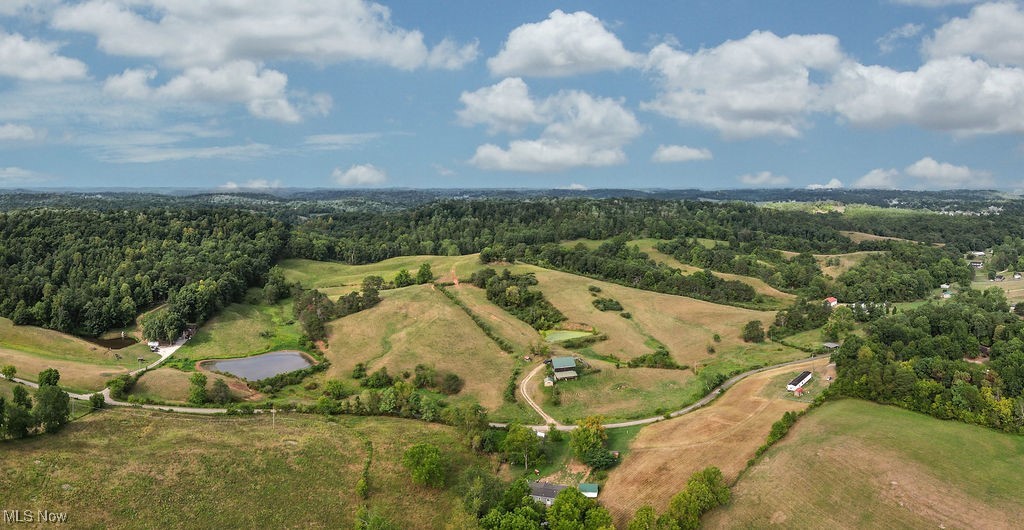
702, 400, 1024, 529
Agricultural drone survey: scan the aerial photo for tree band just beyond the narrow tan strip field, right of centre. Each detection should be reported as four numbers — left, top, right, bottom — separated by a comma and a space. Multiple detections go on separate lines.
656, 237, 824, 291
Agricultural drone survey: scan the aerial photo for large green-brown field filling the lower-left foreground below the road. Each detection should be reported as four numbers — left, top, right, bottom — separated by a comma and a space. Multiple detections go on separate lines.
0, 409, 489, 528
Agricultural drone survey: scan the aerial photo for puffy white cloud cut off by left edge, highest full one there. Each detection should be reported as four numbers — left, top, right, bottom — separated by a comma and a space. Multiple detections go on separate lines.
0, 30, 88, 81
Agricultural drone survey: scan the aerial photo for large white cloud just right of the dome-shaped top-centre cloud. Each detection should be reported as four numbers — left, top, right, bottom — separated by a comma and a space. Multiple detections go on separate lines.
643, 31, 845, 138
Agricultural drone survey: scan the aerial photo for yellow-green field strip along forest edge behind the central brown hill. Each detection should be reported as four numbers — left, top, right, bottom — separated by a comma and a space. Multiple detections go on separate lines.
280, 254, 482, 298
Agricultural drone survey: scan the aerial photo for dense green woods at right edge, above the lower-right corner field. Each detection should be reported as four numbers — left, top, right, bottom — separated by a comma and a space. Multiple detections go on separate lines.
830, 288, 1024, 433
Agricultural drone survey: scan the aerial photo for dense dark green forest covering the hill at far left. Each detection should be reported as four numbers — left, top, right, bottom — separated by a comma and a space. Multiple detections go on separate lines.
0, 209, 288, 336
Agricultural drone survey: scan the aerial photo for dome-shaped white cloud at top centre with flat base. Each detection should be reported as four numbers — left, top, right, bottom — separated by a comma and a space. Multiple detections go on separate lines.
487, 9, 642, 77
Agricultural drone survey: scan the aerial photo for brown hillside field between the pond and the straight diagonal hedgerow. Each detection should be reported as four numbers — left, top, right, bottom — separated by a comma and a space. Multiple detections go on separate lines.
326, 285, 515, 409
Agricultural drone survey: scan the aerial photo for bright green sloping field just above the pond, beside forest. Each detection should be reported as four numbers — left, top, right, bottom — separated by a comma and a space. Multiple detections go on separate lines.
174, 290, 302, 361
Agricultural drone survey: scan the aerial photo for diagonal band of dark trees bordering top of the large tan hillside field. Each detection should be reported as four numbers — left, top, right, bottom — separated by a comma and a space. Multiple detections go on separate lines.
522, 236, 757, 303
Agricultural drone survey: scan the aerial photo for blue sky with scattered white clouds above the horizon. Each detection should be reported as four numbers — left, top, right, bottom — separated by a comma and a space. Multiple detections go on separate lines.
0, 0, 1024, 190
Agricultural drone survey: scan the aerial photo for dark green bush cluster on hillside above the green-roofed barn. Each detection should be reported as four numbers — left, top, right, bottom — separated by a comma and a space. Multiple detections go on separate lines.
470, 268, 565, 329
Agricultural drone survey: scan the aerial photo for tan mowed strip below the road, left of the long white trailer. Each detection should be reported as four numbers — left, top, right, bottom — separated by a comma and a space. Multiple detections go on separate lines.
601, 359, 828, 524
